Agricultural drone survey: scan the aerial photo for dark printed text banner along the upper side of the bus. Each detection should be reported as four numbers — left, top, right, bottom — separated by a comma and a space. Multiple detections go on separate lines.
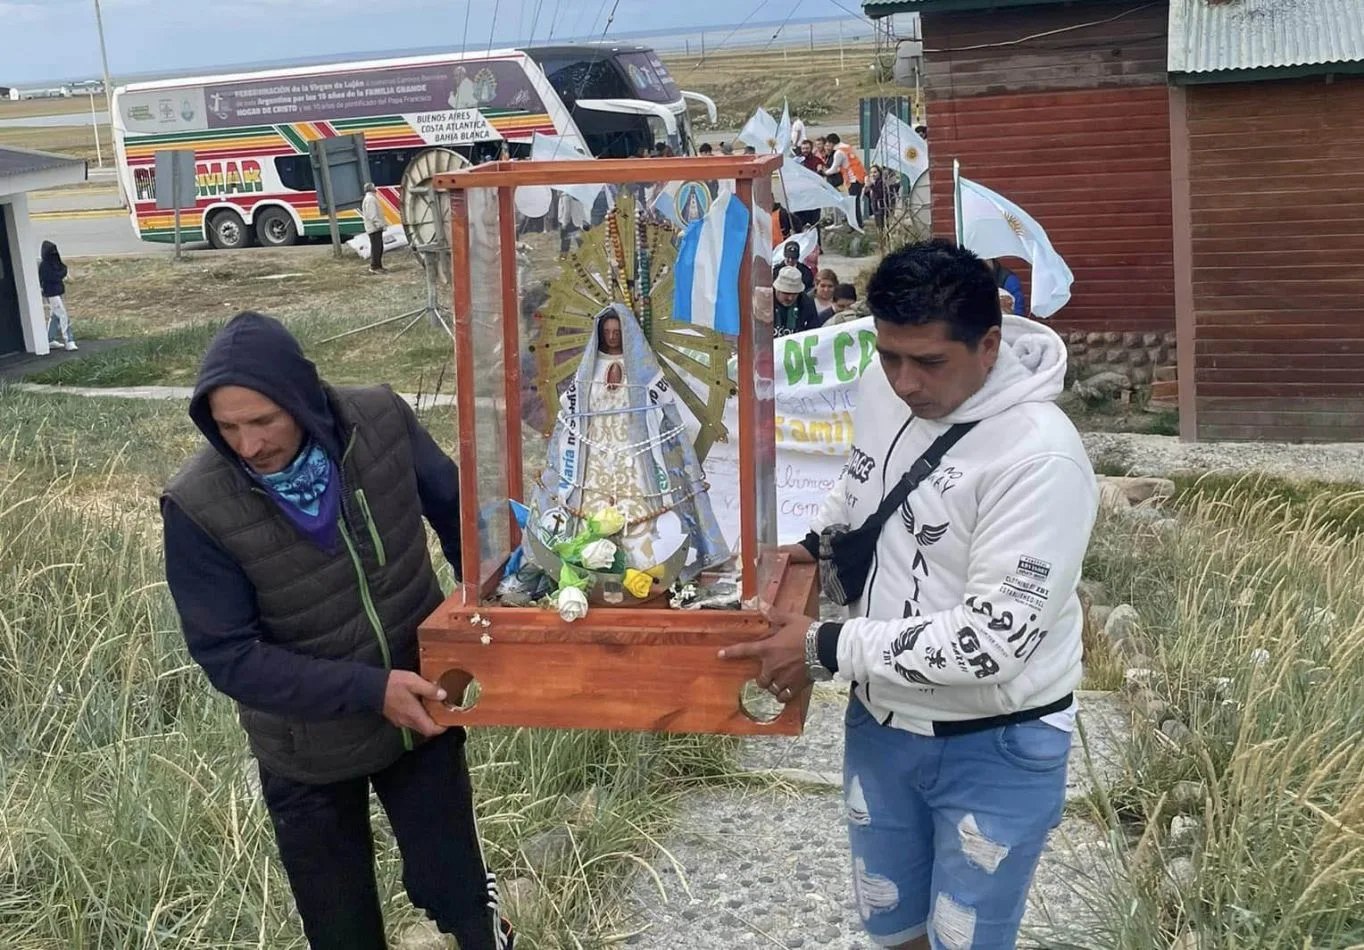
120, 60, 544, 135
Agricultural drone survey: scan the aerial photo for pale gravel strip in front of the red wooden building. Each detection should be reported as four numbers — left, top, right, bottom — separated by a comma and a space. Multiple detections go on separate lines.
1084, 433, 1364, 482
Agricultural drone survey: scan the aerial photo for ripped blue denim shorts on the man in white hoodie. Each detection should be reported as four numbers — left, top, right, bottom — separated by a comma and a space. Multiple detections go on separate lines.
843, 696, 1071, 950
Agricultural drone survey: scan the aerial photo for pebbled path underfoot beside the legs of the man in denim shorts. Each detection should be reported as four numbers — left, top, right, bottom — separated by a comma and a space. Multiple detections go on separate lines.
625, 688, 1127, 950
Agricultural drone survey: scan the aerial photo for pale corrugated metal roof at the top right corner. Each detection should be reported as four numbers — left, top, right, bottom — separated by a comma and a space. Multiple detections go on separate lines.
1169, 0, 1364, 72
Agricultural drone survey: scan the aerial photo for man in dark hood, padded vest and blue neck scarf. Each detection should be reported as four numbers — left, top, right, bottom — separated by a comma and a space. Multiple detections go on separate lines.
161, 313, 512, 950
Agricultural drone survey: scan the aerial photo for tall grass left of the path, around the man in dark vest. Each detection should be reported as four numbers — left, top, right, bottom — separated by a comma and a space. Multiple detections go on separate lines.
0, 389, 731, 950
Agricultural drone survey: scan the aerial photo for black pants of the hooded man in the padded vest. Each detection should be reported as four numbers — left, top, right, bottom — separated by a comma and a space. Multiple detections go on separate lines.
261, 729, 499, 950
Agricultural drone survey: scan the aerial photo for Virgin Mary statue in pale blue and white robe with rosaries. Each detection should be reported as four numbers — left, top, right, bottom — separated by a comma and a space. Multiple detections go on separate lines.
528, 304, 731, 580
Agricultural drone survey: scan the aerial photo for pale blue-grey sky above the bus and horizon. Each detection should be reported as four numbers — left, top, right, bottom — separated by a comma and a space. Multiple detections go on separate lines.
0, 0, 834, 85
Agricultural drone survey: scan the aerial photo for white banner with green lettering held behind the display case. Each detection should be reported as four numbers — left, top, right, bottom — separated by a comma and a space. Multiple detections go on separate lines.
705, 317, 876, 550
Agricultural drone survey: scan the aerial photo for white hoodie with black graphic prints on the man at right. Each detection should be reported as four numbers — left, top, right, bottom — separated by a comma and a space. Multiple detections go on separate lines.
812, 315, 1098, 734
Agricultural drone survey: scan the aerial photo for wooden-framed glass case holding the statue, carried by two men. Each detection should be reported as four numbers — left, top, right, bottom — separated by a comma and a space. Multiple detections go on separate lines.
419, 153, 818, 734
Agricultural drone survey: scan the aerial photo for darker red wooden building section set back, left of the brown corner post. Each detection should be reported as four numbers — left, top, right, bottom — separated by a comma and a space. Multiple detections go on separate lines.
863, 0, 1174, 345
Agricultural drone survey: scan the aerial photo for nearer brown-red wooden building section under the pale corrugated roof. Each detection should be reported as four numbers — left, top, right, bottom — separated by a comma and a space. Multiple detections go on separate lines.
1169, 0, 1364, 441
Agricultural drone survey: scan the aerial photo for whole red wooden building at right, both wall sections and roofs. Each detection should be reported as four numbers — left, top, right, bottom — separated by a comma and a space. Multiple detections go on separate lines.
863, 0, 1364, 441
